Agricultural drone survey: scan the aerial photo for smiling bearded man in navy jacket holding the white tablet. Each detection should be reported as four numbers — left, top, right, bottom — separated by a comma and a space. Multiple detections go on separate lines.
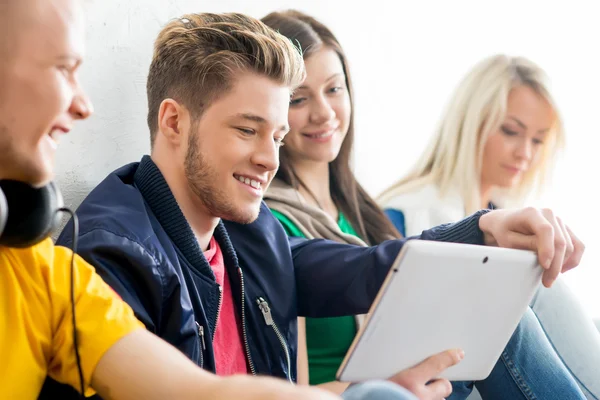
54, 9, 583, 399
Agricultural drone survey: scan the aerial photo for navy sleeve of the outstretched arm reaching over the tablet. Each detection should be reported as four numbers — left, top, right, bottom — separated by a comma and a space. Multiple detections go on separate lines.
289, 210, 487, 318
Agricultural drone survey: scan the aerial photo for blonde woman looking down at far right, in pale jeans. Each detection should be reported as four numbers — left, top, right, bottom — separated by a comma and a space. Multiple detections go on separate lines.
378, 55, 600, 399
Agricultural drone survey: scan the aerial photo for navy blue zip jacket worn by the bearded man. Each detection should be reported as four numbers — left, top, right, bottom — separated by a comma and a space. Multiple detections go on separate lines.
47, 156, 483, 394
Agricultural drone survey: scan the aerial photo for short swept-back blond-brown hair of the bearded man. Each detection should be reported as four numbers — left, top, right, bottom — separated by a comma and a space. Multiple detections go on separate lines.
146, 13, 305, 144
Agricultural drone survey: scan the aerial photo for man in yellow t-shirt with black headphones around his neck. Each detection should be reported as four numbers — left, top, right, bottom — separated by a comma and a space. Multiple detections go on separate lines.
0, 0, 432, 400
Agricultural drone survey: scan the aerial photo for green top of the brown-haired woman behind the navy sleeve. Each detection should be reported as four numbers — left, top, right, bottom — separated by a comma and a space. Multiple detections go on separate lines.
271, 210, 358, 385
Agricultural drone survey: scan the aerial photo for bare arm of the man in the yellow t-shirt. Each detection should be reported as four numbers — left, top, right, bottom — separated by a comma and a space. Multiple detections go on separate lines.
92, 329, 339, 400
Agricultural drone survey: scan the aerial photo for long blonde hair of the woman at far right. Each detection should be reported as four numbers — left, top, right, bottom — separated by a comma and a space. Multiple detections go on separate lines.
378, 55, 564, 213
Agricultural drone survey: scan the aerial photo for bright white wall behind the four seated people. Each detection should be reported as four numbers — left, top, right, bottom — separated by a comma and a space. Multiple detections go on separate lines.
58, 0, 600, 317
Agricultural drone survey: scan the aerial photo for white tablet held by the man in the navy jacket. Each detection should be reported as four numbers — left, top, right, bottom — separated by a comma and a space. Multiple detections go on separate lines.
337, 240, 543, 382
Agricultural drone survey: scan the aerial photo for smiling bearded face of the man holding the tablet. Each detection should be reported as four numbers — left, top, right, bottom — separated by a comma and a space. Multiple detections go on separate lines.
184, 72, 291, 223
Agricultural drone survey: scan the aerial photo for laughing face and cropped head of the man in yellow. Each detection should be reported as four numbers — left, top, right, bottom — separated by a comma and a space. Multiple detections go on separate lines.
0, 0, 91, 186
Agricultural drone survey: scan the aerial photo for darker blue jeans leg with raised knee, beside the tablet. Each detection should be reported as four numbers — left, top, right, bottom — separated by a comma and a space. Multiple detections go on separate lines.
448, 308, 585, 400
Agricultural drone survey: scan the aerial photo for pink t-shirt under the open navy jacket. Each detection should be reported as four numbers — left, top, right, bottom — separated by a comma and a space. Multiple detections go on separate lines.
204, 236, 248, 376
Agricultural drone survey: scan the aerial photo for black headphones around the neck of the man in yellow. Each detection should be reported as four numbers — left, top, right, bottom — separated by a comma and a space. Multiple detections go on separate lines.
0, 180, 64, 248
